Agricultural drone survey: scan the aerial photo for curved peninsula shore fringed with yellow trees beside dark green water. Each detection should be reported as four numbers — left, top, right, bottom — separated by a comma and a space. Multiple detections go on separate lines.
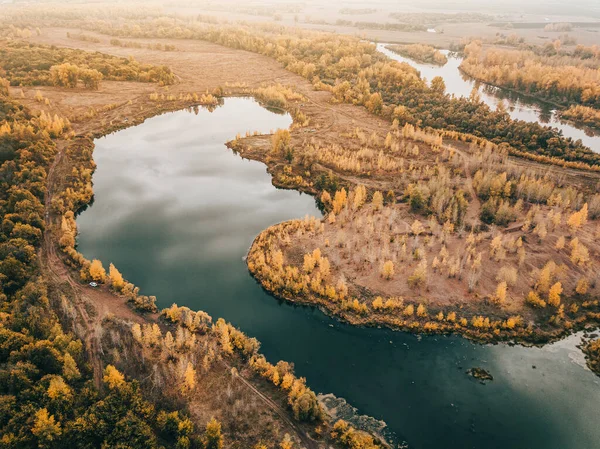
247, 217, 600, 345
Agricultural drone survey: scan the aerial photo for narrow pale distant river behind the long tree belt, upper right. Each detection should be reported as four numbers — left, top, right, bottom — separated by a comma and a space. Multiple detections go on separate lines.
377, 44, 600, 153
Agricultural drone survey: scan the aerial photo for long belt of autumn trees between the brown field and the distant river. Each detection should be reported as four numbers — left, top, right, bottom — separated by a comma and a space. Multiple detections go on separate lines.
56, 19, 600, 167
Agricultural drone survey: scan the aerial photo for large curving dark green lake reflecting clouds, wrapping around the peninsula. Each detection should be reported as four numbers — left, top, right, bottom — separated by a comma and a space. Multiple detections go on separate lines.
78, 99, 600, 449
